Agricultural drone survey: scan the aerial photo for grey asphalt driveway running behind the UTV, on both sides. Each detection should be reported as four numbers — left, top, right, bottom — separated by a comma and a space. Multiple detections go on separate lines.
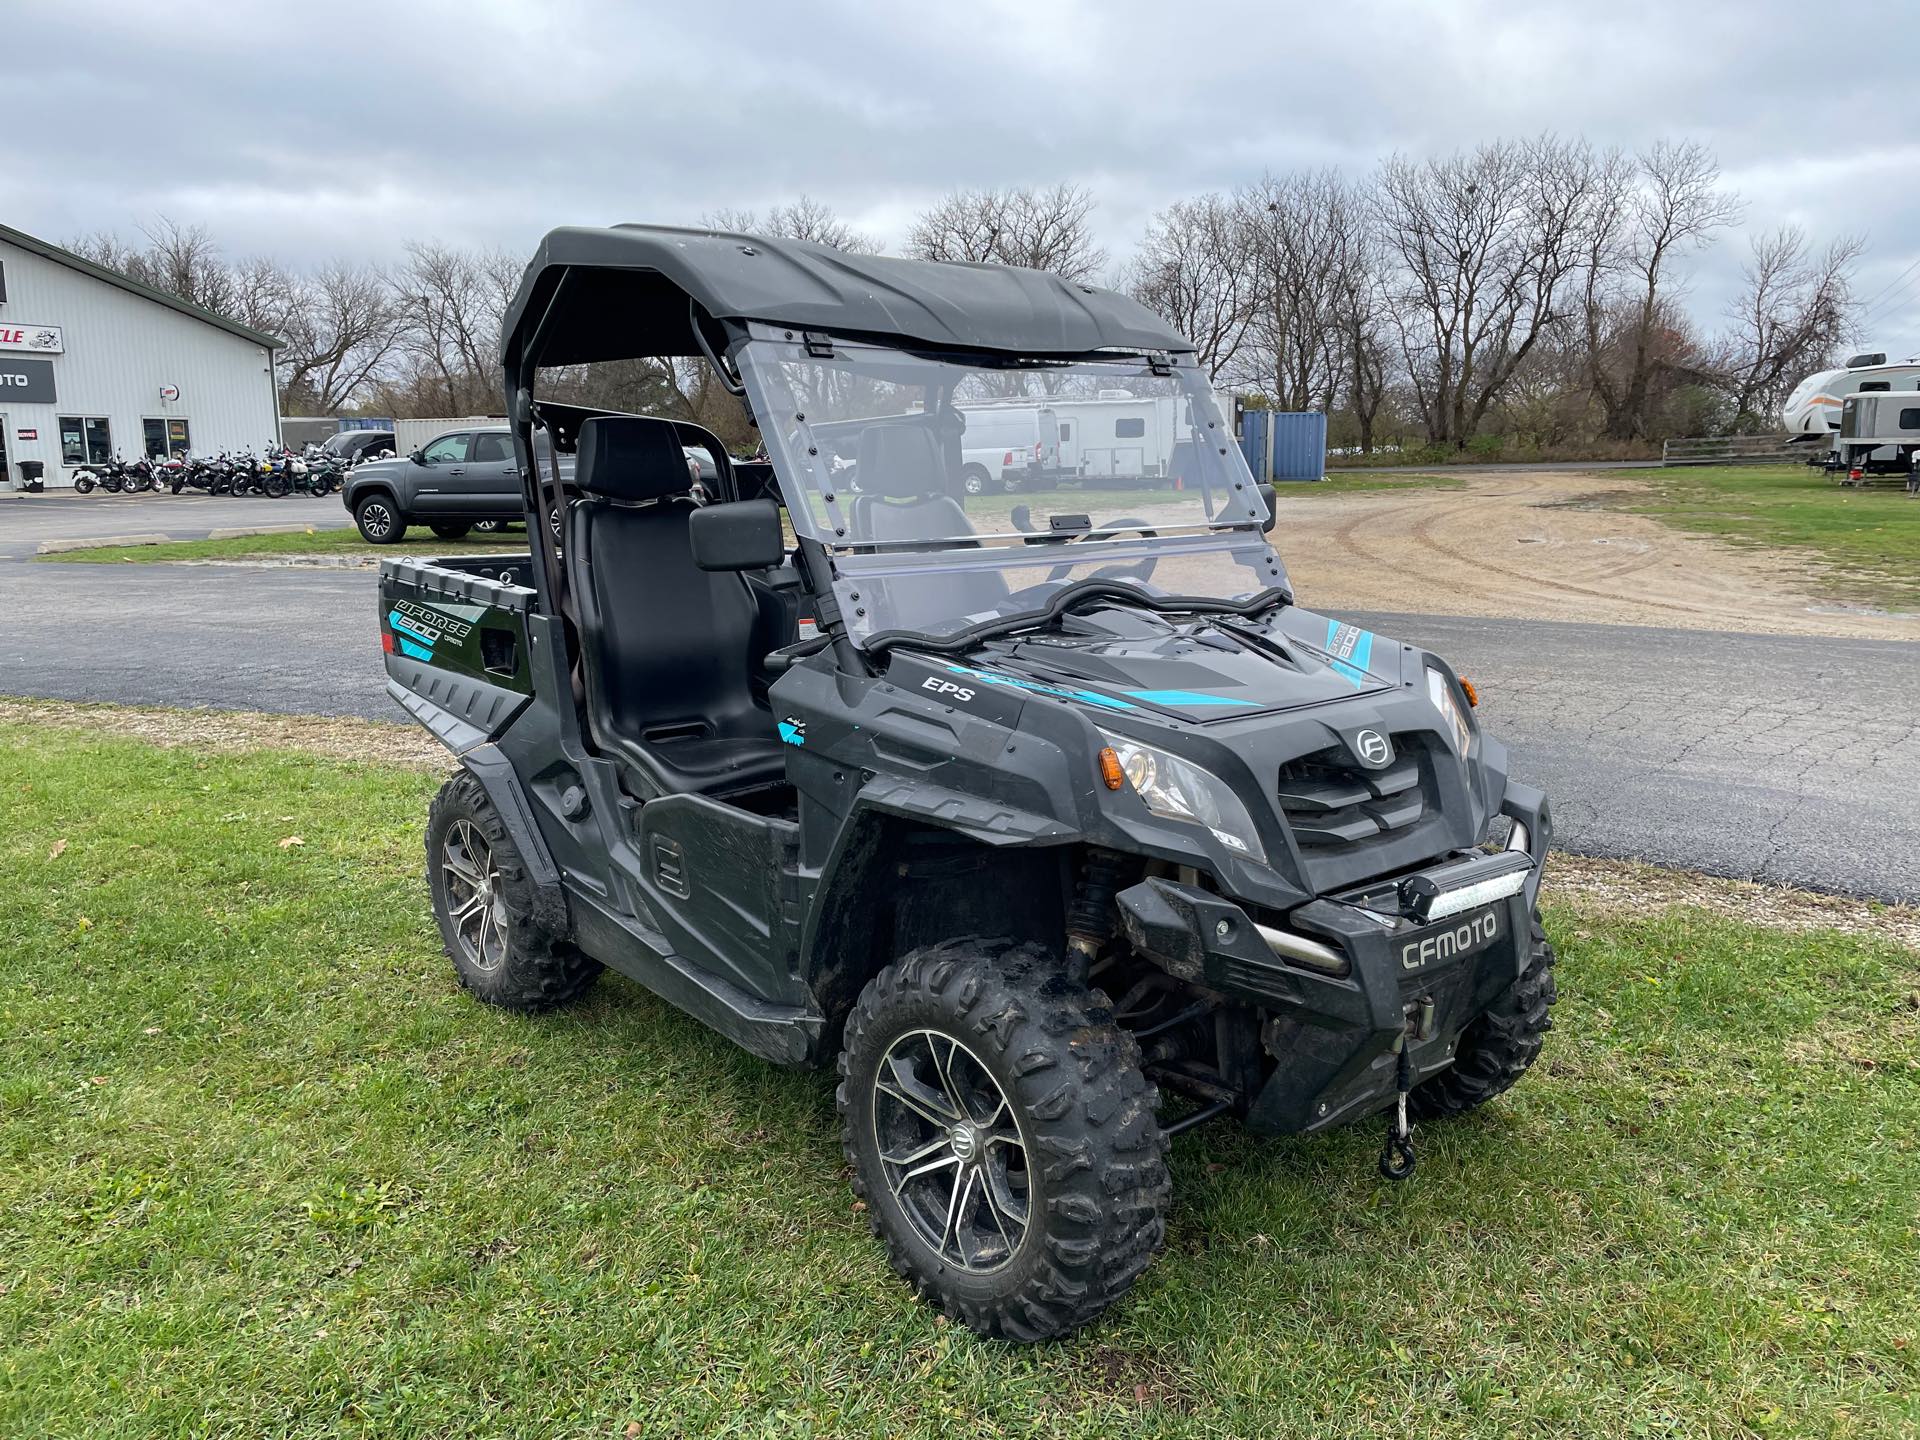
0, 564, 1920, 902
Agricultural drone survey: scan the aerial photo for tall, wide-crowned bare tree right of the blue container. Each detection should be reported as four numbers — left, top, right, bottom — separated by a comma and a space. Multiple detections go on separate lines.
1375, 136, 1601, 445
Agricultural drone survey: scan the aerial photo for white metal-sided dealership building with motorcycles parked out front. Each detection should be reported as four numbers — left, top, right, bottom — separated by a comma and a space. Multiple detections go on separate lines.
0, 225, 280, 488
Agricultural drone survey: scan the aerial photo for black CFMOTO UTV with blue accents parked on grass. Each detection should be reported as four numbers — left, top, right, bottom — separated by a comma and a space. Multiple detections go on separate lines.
380, 227, 1553, 1340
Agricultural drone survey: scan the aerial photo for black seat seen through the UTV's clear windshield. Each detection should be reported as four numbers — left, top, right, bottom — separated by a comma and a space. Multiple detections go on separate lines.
851, 424, 1008, 628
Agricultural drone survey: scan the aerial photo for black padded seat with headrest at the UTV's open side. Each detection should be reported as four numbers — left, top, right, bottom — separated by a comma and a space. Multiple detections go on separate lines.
564, 417, 770, 768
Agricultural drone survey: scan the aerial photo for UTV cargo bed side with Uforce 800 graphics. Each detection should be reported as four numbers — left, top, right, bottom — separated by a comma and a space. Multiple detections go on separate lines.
380, 555, 538, 755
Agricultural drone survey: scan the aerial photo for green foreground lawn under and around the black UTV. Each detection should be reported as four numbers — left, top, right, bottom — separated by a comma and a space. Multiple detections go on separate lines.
0, 724, 1920, 1440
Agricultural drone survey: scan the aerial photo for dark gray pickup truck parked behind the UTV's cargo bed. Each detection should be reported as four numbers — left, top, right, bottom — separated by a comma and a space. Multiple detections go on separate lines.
340, 426, 545, 545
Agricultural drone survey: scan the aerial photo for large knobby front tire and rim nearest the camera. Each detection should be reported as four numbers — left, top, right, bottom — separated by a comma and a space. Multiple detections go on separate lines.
837, 937, 1171, 1340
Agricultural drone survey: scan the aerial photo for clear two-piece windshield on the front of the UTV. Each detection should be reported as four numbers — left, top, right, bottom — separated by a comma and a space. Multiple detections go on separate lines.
739, 330, 1286, 637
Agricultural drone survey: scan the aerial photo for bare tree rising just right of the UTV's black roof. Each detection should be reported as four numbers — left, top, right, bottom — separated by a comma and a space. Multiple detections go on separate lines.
1125, 194, 1256, 382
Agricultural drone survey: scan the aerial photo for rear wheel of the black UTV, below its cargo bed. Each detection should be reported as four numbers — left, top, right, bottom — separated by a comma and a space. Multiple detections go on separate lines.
426, 770, 601, 1012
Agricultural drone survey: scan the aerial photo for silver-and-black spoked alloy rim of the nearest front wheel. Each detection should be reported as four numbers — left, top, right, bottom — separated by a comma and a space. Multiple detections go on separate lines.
874, 1029, 1033, 1271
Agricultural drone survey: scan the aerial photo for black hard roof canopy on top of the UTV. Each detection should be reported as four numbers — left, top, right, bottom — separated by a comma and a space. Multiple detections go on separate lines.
501, 225, 1192, 367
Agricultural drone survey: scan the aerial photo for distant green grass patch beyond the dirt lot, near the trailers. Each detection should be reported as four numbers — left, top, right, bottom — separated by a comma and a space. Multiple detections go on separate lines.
1622, 465, 1920, 611
